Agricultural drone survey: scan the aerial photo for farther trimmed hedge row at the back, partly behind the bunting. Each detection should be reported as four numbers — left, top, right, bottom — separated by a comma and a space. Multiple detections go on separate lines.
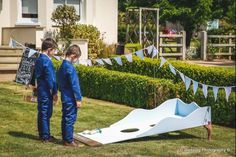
105, 57, 235, 86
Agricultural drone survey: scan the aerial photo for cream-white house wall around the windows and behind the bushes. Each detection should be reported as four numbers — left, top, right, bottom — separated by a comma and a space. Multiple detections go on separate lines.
0, 0, 118, 45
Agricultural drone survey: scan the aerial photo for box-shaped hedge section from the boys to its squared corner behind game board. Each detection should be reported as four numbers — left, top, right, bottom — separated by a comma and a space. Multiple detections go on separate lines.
54, 59, 176, 108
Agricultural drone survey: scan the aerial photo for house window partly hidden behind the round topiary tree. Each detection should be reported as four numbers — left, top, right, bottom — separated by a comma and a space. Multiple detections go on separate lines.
54, 0, 80, 16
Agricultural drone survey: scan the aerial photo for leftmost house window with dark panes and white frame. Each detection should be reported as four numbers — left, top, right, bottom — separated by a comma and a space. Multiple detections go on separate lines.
22, 0, 38, 18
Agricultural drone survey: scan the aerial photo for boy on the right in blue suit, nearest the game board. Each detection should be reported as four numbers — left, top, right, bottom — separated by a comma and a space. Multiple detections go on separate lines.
58, 45, 82, 147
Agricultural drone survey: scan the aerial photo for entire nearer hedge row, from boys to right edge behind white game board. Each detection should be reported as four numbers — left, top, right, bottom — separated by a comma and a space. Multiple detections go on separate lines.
55, 60, 235, 126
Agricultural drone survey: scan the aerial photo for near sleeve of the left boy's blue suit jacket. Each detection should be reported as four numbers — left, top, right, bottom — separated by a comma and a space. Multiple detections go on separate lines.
44, 62, 57, 95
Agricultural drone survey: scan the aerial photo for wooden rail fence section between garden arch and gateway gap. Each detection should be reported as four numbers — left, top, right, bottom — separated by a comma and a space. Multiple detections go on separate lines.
159, 31, 186, 60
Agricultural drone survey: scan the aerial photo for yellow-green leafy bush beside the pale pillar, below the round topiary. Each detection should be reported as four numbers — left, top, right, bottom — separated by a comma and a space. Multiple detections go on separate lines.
73, 24, 105, 59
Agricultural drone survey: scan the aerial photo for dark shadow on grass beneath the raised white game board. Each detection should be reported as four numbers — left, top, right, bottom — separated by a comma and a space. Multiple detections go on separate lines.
118, 131, 203, 143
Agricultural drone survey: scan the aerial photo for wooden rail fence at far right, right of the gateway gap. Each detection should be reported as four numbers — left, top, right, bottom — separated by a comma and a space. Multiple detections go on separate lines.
201, 31, 235, 60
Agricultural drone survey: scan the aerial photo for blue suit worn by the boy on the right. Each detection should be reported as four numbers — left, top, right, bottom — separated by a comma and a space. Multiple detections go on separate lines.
58, 60, 82, 143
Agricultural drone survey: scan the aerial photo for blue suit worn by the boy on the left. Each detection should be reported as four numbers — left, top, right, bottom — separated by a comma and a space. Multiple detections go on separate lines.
35, 54, 57, 140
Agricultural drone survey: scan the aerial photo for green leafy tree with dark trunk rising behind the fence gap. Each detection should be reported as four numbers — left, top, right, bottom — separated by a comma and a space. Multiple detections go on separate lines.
154, 0, 212, 48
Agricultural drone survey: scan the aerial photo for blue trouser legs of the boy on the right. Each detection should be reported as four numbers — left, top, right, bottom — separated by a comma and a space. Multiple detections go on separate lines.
61, 102, 77, 143
